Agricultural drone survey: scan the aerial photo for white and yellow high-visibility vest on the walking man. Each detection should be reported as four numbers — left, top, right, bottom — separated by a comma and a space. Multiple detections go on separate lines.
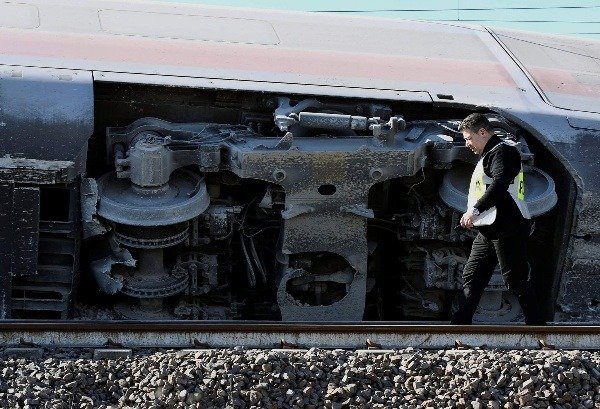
467, 141, 531, 226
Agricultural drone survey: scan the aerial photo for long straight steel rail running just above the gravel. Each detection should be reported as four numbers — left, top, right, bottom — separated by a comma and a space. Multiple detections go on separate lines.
0, 321, 600, 350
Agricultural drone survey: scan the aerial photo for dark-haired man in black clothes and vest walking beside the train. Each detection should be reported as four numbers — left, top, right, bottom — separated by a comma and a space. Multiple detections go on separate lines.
451, 114, 545, 325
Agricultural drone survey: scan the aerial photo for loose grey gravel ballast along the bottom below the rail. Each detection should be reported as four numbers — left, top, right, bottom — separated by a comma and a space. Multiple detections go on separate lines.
0, 348, 600, 408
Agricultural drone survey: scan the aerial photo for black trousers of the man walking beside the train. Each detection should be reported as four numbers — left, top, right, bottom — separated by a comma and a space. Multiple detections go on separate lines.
451, 233, 545, 325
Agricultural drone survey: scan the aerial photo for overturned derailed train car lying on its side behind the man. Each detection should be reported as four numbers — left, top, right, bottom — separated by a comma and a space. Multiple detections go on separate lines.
0, 0, 600, 322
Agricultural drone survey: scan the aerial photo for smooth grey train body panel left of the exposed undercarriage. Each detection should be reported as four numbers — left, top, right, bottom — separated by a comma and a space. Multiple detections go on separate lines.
0, 65, 94, 177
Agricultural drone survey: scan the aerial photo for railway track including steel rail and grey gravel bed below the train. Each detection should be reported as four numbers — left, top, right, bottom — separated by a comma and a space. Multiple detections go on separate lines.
0, 321, 600, 409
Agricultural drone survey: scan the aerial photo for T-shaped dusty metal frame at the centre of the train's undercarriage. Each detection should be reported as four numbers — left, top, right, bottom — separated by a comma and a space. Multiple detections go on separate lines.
231, 138, 419, 321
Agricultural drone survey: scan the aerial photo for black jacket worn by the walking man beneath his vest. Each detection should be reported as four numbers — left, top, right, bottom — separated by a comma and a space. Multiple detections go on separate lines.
475, 135, 531, 239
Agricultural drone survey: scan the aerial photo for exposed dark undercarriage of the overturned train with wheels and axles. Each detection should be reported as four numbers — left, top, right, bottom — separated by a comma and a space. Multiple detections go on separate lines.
5, 83, 572, 323
